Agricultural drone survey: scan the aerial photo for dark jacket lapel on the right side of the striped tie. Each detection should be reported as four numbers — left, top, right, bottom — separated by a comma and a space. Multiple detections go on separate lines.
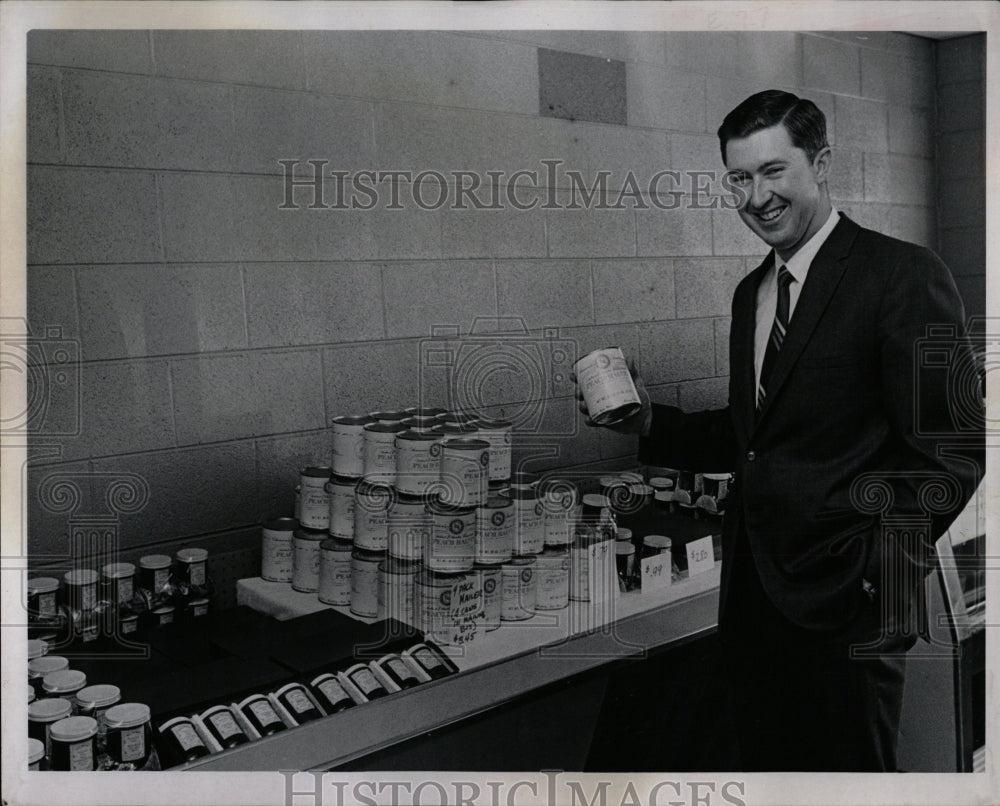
756, 216, 859, 425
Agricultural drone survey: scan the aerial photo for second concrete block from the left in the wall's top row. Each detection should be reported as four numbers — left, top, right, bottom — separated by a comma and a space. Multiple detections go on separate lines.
152, 30, 305, 89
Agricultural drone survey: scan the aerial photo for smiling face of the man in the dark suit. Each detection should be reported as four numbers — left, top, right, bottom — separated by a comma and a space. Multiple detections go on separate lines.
726, 123, 830, 259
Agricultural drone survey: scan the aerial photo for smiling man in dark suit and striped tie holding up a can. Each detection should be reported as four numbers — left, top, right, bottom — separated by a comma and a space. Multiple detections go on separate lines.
580, 90, 982, 771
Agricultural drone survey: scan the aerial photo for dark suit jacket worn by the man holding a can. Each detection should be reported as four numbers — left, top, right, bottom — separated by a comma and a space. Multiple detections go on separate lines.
639, 216, 984, 629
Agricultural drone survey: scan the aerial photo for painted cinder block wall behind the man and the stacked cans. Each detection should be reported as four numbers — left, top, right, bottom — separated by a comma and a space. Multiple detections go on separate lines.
26, 26, 938, 573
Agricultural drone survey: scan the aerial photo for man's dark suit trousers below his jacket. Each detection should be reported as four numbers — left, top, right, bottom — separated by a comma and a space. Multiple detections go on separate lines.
719, 538, 914, 772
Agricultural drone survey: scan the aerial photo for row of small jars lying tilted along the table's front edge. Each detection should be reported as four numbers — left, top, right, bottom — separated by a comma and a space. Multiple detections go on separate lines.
157, 643, 454, 766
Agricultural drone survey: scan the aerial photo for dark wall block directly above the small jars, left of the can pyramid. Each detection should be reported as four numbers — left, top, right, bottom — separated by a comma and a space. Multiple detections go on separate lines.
94, 441, 259, 553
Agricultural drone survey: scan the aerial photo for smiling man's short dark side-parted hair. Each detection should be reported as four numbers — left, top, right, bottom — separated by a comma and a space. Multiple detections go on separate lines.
719, 90, 829, 164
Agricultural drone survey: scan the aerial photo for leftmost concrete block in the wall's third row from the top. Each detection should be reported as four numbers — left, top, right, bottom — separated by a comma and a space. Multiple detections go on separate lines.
27, 166, 162, 263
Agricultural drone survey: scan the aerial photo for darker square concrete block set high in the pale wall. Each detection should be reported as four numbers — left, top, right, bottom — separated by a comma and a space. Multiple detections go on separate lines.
538, 48, 628, 126
